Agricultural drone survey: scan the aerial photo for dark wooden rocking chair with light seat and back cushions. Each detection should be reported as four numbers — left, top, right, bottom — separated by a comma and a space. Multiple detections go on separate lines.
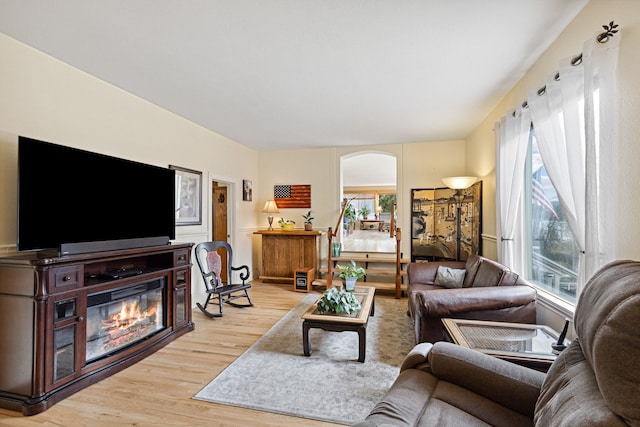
195, 241, 253, 318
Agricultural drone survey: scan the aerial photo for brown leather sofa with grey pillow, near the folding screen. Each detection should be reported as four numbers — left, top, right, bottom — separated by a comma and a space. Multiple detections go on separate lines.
407, 255, 536, 343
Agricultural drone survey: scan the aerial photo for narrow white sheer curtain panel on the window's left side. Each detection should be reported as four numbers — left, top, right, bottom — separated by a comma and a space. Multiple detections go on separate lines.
494, 108, 531, 271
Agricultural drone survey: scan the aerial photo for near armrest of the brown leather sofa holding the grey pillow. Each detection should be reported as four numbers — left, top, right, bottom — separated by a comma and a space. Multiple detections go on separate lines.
413, 285, 536, 317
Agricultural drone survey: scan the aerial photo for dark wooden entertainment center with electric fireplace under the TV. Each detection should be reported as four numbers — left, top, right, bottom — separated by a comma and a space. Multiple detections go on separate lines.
0, 243, 194, 415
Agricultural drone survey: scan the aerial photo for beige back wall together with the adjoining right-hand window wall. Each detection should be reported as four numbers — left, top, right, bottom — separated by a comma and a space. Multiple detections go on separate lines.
260, 0, 640, 329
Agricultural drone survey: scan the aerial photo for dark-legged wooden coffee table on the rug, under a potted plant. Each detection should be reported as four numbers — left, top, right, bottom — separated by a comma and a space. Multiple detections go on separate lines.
302, 286, 376, 362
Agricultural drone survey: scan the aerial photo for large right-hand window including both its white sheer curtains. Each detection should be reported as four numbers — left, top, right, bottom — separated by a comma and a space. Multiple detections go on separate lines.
496, 38, 624, 306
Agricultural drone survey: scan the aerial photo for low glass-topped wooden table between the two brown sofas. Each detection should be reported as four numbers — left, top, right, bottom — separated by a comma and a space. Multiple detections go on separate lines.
442, 319, 569, 372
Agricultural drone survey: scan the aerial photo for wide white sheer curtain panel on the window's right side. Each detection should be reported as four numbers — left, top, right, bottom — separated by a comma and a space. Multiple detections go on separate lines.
528, 32, 620, 294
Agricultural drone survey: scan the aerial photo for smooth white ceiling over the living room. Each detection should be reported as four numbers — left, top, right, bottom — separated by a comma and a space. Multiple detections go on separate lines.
0, 0, 588, 151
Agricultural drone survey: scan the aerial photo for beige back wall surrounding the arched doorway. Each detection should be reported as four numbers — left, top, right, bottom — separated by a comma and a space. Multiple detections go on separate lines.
254, 140, 465, 274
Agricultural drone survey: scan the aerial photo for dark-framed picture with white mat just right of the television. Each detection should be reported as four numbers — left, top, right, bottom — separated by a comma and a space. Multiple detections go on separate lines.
169, 165, 202, 226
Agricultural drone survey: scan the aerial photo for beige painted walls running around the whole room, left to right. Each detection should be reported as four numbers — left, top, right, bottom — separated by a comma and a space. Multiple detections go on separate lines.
0, 0, 640, 318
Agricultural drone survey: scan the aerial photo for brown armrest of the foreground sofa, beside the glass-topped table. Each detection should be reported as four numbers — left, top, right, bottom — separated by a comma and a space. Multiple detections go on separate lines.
429, 342, 545, 417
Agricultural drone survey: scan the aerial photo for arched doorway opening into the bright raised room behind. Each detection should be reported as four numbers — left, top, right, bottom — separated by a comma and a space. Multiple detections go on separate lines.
341, 151, 397, 253
